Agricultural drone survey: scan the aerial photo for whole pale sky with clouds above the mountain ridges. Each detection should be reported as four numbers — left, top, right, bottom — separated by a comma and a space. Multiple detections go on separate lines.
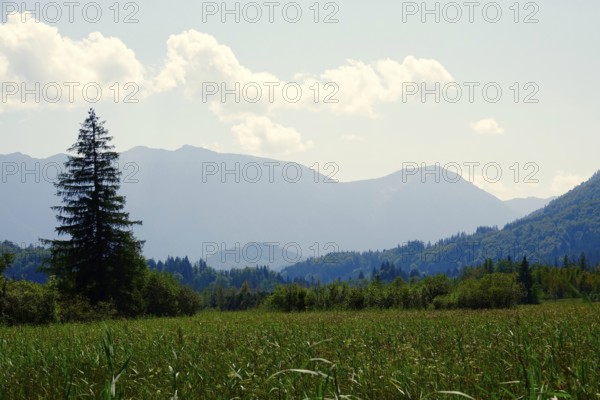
0, 0, 600, 200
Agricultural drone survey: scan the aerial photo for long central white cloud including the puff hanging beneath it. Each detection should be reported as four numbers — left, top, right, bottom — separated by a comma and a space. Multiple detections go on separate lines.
150, 30, 452, 153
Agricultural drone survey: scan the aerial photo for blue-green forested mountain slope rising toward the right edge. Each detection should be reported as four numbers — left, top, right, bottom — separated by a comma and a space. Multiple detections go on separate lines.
282, 172, 600, 282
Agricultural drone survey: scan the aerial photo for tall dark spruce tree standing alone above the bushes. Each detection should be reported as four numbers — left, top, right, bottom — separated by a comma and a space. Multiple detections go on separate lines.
46, 109, 146, 314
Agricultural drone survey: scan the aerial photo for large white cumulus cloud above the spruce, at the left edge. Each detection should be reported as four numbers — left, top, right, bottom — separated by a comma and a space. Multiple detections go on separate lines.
0, 14, 145, 111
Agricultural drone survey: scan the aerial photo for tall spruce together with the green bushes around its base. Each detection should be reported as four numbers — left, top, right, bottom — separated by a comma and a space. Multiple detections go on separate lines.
0, 109, 200, 325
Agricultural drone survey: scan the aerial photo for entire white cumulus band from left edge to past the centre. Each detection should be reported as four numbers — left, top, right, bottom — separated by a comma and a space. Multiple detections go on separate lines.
0, 18, 452, 154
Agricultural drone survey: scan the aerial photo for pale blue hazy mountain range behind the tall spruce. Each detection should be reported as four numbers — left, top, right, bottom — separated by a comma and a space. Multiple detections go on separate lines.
0, 146, 546, 268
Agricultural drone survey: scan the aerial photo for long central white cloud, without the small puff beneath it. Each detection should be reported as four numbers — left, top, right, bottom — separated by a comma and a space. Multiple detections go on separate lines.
152, 30, 452, 118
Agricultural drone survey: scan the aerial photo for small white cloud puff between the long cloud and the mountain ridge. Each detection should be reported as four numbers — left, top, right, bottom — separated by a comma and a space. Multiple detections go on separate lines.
231, 116, 313, 154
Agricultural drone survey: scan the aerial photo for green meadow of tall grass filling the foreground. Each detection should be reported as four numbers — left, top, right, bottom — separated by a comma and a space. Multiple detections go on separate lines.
0, 303, 600, 400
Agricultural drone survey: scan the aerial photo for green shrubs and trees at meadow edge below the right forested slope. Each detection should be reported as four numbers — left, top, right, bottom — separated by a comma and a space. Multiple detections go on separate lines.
266, 258, 600, 312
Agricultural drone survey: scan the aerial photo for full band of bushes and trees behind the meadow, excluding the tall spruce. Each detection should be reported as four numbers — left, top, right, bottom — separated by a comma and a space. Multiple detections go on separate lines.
0, 244, 600, 325
